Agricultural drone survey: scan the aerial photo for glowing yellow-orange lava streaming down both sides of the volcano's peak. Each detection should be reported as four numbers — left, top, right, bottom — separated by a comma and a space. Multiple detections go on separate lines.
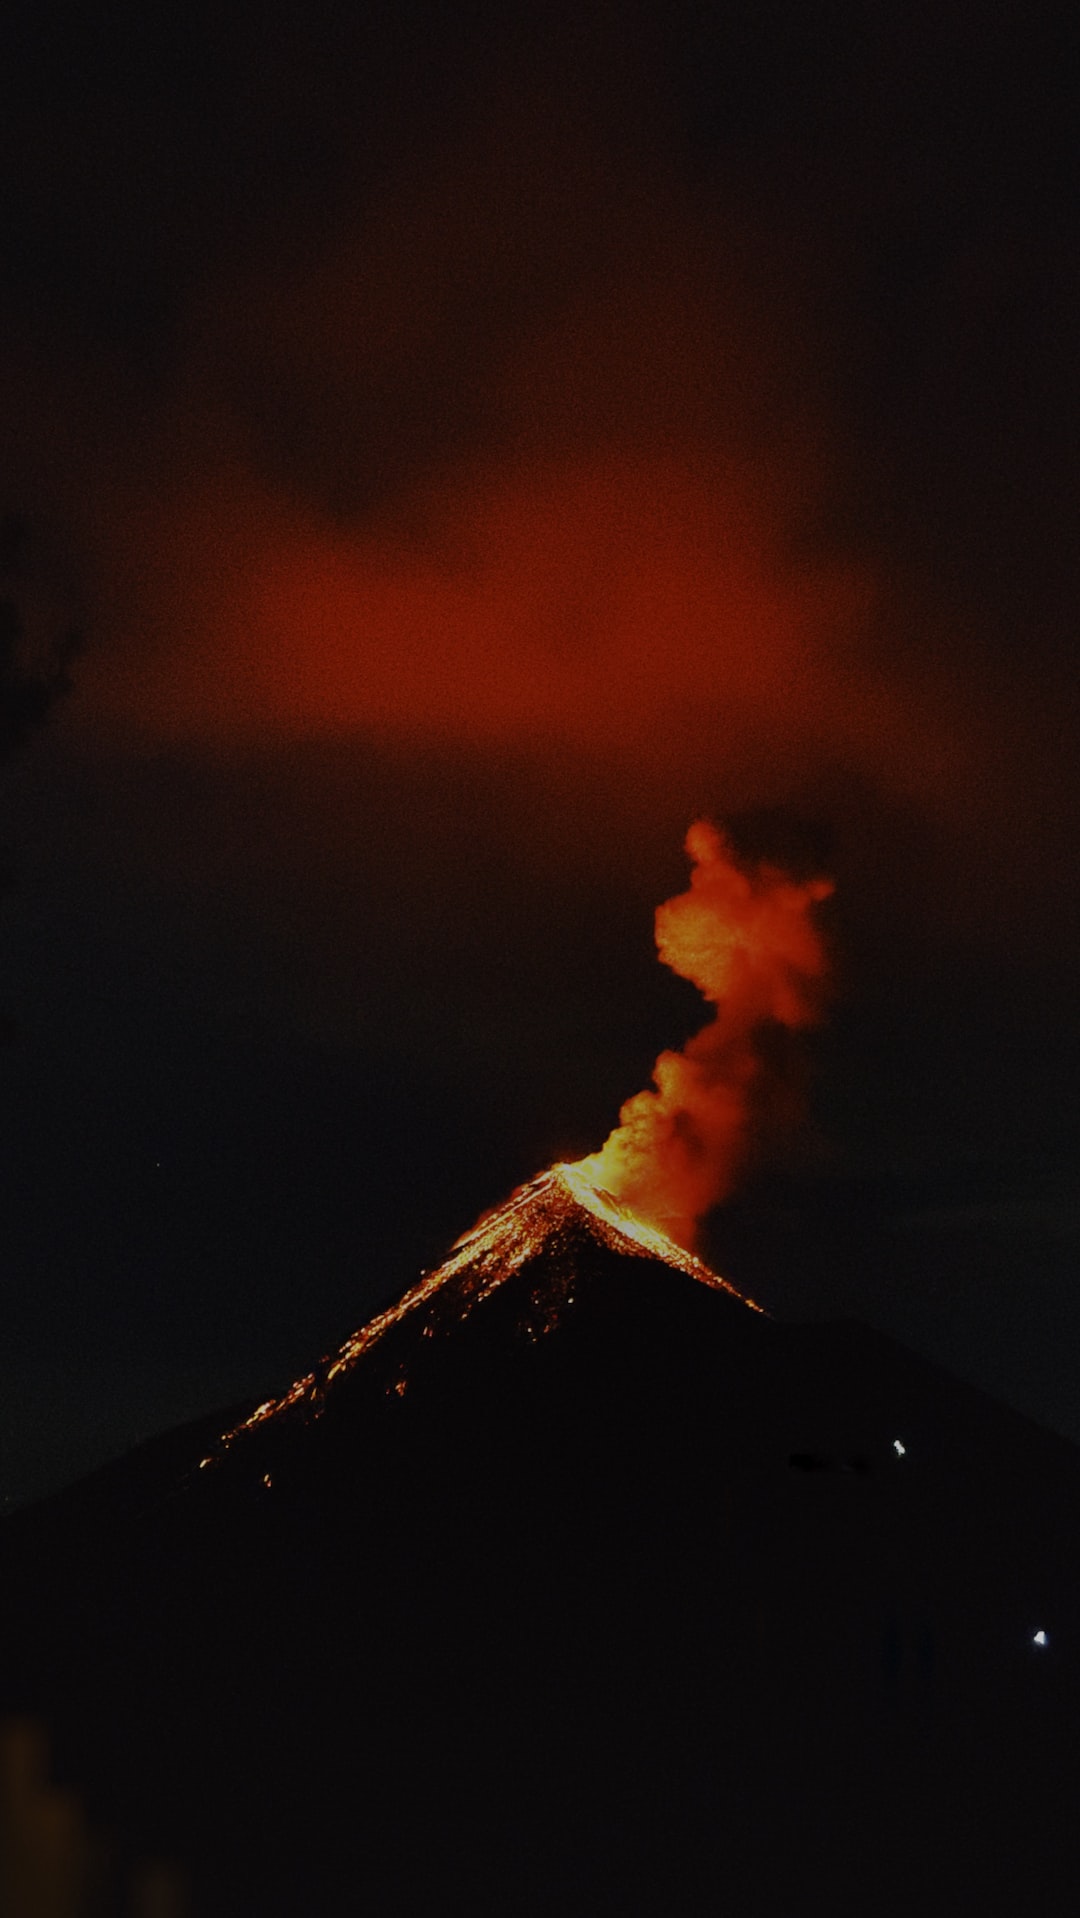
201, 1164, 762, 1465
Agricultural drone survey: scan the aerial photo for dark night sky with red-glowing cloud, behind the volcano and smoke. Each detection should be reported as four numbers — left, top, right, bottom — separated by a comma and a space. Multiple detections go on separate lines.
0, 0, 1080, 1500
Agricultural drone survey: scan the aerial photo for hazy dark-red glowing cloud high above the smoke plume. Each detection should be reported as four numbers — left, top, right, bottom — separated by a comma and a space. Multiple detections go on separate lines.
57, 127, 939, 824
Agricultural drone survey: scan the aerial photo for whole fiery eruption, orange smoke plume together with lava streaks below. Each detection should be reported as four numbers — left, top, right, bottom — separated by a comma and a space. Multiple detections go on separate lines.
203, 821, 833, 1457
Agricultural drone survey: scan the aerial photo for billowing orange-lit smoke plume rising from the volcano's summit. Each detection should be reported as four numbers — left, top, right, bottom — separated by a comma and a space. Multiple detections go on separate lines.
581, 819, 833, 1245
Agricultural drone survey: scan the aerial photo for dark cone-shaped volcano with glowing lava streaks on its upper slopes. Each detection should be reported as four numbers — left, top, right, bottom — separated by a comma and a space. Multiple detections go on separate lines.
0, 1166, 1080, 1918
